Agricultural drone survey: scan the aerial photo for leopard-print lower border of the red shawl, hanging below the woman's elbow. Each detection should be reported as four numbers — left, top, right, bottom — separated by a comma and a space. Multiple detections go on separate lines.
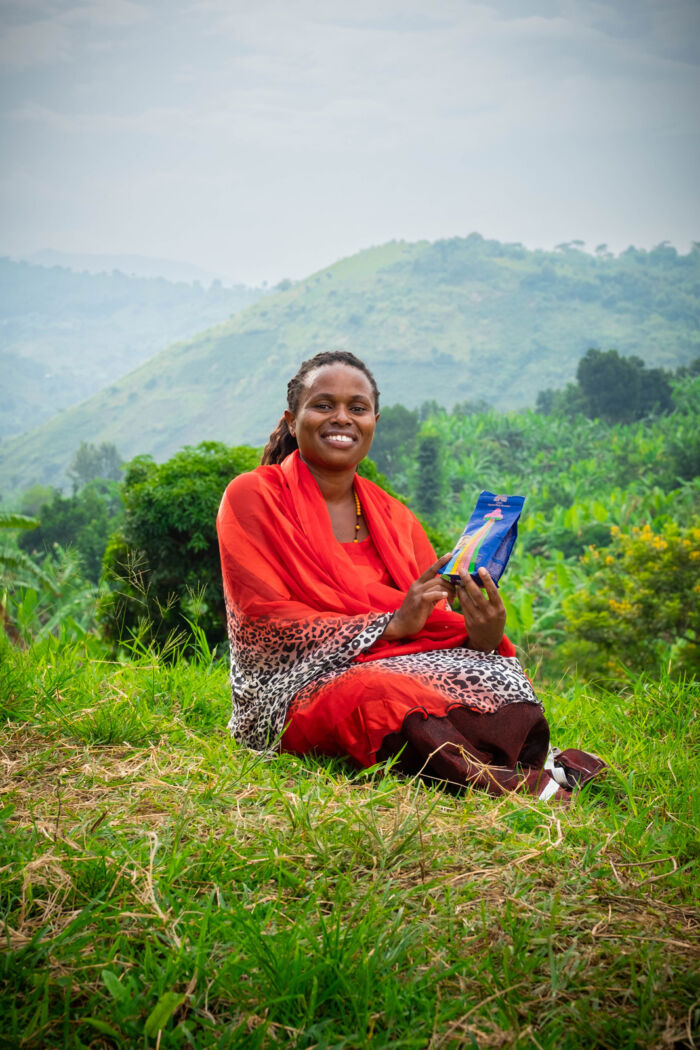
227, 602, 391, 751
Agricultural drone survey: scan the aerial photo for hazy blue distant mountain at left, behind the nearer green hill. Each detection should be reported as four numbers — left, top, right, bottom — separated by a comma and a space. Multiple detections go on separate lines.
0, 259, 262, 437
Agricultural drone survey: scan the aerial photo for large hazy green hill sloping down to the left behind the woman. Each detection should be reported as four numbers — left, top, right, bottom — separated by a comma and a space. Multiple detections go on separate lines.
0, 234, 700, 488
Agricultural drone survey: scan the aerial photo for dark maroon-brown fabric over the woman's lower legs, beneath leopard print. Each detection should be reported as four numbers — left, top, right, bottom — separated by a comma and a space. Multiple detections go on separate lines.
377, 704, 550, 795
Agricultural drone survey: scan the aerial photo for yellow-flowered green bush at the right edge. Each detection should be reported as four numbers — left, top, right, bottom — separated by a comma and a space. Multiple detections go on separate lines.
564, 516, 700, 675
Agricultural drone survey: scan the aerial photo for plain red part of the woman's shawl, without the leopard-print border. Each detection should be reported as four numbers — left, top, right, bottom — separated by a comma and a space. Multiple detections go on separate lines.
217, 452, 515, 660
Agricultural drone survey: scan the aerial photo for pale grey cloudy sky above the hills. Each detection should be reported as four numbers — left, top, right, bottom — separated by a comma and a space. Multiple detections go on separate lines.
0, 0, 700, 285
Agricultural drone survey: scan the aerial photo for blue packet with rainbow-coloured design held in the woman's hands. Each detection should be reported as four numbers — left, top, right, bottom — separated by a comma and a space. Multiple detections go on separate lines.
439, 491, 525, 585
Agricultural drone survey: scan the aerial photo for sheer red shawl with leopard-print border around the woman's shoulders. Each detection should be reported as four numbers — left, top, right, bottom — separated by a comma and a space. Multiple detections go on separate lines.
216, 452, 514, 746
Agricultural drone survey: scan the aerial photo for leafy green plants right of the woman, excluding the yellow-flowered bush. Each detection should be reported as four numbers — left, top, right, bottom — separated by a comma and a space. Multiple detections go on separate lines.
377, 394, 700, 676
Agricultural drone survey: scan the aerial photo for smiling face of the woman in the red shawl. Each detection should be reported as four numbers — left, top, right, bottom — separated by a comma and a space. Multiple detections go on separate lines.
284, 364, 379, 470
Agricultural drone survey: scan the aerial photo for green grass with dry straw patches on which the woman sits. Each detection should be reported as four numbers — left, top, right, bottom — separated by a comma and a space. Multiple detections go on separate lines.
0, 639, 700, 1050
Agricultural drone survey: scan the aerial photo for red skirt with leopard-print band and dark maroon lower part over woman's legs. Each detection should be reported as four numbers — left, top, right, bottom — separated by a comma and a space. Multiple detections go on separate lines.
281, 648, 549, 794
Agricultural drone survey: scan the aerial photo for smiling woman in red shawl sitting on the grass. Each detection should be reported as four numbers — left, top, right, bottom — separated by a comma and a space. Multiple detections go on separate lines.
217, 351, 602, 800
